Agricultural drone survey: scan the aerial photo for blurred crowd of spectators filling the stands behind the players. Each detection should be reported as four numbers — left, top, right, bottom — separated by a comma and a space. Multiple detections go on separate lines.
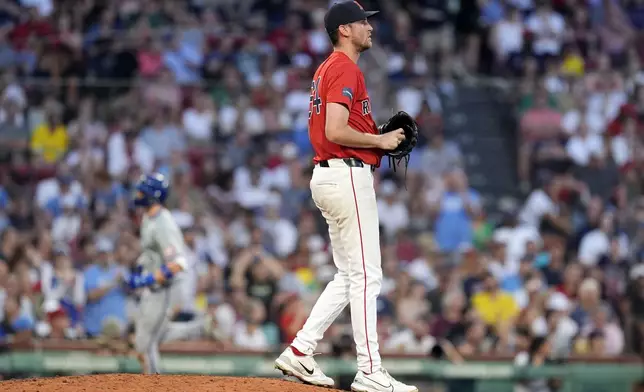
0, 0, 644, 368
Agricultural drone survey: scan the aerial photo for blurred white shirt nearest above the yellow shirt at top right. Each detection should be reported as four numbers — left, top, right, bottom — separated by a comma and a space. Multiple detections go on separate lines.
526, 12, 566, 56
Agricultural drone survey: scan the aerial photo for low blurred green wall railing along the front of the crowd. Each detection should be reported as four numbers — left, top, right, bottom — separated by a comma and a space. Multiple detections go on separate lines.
0, 340, 644, 392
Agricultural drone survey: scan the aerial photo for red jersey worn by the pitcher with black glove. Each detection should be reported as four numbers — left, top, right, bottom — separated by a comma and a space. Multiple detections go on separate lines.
309, 52, 382, 166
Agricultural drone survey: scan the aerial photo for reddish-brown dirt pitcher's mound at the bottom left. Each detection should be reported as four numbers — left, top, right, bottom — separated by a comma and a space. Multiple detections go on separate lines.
0, 374, 348, 392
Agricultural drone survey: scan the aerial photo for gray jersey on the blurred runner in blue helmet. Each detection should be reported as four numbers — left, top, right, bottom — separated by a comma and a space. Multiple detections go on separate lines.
137, 208, 187, 281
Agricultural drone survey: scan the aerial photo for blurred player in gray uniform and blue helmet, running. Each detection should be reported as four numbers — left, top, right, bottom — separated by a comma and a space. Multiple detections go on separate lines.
126, 173, 210, 374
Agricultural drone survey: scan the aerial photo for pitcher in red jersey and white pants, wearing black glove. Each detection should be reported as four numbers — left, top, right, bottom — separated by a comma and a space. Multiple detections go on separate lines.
275, 1, 426, 392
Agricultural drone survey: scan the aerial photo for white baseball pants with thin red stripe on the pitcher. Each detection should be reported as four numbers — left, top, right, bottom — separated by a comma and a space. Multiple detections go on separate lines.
292, 159, 382, 374
